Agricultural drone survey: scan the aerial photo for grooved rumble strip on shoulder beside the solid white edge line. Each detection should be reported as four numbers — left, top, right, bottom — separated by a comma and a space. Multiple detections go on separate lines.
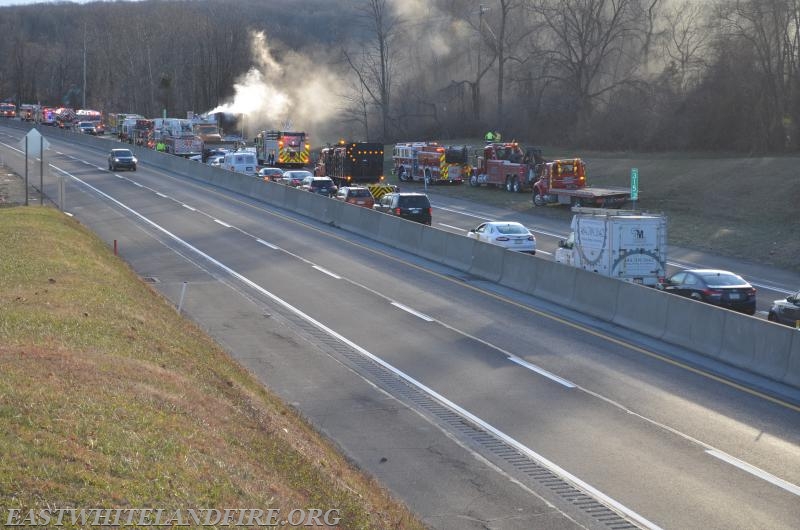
256, 294, 640, 530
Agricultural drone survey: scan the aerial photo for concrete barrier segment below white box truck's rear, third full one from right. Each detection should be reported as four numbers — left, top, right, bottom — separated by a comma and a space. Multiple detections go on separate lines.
612, 282, 672, 338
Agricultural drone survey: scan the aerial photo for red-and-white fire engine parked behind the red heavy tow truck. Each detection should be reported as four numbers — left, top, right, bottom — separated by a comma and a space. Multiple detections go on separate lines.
392, 142, 472, 184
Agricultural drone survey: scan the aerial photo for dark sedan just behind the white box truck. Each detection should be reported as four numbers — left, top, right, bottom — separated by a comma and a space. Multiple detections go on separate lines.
659, 269, 756, 315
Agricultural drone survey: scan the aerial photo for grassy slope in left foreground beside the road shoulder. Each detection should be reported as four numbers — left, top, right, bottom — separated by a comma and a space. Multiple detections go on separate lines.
0, 208, 421, 528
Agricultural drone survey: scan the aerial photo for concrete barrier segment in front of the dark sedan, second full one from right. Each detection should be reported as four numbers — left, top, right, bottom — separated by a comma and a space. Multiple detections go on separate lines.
662, 295, 725, 359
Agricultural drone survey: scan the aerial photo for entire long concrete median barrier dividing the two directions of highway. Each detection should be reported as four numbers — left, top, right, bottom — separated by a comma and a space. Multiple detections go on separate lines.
3, 119, 800, 389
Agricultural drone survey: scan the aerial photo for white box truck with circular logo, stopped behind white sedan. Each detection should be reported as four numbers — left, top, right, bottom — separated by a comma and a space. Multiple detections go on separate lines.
555, 207, 667, 287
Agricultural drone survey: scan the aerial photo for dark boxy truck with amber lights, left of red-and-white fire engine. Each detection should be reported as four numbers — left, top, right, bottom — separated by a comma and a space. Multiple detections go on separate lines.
314, 141, 384, 186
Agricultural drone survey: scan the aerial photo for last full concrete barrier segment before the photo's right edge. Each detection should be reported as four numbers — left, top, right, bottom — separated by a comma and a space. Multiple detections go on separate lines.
720, 311, 792, 381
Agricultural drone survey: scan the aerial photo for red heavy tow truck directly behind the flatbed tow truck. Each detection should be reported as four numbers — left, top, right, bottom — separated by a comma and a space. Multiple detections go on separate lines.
469, 142, 544, 193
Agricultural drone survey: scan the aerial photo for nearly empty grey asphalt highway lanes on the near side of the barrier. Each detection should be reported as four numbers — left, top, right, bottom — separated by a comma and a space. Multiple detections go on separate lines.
0, 128, 800, 529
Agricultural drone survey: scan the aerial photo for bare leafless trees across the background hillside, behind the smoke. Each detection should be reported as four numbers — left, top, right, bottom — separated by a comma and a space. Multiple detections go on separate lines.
0, 0, 800, 154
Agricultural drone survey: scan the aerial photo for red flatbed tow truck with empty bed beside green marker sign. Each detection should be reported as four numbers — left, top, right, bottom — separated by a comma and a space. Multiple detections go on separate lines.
531, 158, 631, 208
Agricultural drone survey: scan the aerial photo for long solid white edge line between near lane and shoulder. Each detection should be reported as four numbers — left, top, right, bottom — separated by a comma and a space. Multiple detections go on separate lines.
43, 162, 661, 530
